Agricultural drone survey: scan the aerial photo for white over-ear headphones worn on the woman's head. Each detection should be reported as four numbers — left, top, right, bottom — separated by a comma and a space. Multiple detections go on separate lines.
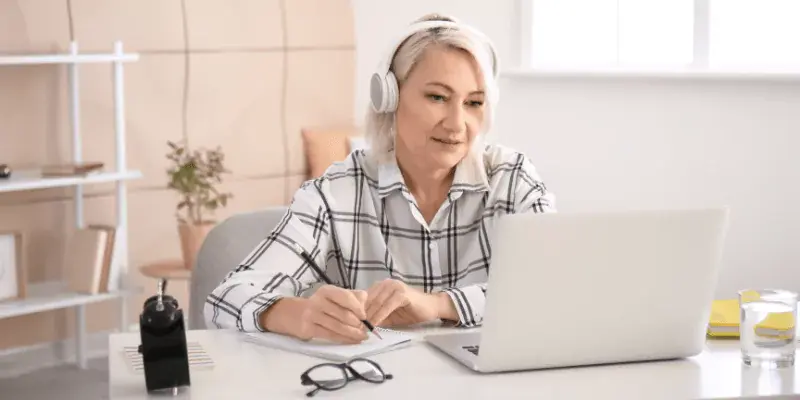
369, 21, 498, 113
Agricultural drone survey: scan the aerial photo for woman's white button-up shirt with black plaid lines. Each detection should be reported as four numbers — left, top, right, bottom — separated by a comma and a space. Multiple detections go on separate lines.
204, 145, 555, 332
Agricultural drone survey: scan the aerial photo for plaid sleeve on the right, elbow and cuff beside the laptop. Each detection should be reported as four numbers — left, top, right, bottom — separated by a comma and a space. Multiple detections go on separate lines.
434, 154, 556, 328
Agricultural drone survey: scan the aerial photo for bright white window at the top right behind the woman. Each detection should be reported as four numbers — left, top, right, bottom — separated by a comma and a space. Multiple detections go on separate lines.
523, 0, 800, 69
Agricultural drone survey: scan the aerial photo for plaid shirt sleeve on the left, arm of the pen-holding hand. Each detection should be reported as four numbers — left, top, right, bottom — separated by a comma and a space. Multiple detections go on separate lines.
203, 180, 332, 332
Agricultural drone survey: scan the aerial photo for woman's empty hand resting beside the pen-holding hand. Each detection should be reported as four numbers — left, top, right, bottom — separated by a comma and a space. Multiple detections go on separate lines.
366, 279, 441, 326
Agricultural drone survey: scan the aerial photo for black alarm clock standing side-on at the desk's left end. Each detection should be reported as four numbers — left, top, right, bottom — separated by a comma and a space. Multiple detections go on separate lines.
139, 279, 191, 394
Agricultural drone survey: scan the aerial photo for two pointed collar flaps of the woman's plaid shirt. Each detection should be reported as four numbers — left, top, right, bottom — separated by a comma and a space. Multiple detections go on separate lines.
378, 152, 489, 198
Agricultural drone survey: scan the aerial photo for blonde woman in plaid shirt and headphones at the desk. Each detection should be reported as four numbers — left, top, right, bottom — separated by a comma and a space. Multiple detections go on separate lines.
204, 15, 554, 343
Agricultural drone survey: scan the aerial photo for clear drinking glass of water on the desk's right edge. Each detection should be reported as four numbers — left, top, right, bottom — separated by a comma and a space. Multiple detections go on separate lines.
739, 289, 798, 368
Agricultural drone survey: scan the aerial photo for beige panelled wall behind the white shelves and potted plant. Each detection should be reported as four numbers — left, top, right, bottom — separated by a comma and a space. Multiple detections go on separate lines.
0, 0, 355, 349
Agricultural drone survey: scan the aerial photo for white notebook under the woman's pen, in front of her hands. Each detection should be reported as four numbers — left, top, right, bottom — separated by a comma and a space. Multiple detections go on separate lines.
246, 328, 413, 361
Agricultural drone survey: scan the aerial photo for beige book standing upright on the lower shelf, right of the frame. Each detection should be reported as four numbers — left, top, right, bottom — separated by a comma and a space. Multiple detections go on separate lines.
64, 225, 117, 294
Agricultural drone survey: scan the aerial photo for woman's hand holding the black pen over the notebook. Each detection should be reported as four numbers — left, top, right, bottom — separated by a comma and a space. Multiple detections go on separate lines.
264, 285, 367, 343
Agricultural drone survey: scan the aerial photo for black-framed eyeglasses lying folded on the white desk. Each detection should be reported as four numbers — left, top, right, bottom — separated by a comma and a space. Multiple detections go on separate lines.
300, 358, 392, 397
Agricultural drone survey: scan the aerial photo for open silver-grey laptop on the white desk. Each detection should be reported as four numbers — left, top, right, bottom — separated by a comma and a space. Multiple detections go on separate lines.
425, 208, 728, 372
